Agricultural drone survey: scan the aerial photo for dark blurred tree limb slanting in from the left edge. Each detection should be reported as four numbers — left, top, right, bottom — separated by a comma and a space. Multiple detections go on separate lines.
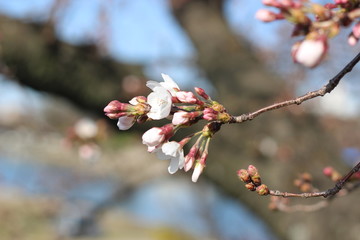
0, 16, 145, 114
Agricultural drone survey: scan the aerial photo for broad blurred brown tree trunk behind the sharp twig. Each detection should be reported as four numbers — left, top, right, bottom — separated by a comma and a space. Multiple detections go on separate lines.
173, 0, 356, 239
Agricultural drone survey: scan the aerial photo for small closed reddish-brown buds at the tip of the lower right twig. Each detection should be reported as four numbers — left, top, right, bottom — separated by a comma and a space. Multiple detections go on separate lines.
237, 165, 270, 196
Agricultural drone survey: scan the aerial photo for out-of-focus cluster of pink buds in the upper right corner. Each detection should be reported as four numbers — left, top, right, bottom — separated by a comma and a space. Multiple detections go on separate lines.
255, 0, 360, 68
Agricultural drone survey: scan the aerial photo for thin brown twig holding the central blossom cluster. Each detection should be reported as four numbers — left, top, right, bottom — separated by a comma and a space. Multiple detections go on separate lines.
229, 53, 360, 123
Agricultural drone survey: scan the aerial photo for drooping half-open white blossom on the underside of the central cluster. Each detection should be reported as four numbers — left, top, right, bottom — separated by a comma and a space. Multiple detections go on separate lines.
156, 141, 185, 174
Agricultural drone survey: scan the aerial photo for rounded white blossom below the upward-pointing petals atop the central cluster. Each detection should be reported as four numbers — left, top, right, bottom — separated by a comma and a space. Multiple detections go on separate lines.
147, 87, 172, 120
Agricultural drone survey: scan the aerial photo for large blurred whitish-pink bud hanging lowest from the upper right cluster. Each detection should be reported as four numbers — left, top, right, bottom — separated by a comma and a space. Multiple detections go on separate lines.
292, 37, 327, 68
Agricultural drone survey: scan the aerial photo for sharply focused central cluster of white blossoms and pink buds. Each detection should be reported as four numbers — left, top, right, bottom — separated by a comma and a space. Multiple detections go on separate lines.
104, 74, 232, 182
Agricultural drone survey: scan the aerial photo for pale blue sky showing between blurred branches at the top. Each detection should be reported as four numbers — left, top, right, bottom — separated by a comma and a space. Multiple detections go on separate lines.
0, 0, 359, 116
